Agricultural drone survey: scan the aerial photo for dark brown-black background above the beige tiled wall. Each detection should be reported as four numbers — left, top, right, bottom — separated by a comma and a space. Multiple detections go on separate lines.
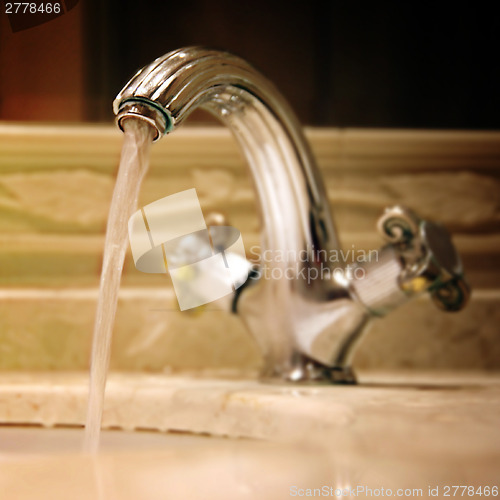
0, 0, 500, 129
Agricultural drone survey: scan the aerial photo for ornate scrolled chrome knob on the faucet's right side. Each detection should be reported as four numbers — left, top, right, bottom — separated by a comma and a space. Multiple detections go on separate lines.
377, 206, 470, 311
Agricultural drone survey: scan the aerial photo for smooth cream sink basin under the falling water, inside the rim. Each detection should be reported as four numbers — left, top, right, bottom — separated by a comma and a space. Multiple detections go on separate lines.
0, 426, 336, 500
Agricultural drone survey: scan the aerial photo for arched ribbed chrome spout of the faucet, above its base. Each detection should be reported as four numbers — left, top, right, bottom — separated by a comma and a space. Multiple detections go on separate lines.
114, 47, 338, 272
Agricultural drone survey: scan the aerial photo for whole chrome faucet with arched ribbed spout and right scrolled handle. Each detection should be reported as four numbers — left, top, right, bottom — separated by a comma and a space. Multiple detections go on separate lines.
113, 47, 469, 383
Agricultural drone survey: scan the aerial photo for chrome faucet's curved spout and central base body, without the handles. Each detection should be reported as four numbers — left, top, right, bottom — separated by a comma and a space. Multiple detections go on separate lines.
113, 47, 468, 382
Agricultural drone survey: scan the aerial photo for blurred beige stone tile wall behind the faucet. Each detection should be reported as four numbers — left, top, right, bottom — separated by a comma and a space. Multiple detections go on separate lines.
0, 125, 500, 370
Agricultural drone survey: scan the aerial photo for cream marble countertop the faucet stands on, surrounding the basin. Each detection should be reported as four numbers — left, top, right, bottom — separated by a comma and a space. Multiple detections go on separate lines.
0, 372, 500, 498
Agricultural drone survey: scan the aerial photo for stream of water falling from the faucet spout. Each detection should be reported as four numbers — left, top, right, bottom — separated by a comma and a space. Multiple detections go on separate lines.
84, 119, 153, 453
